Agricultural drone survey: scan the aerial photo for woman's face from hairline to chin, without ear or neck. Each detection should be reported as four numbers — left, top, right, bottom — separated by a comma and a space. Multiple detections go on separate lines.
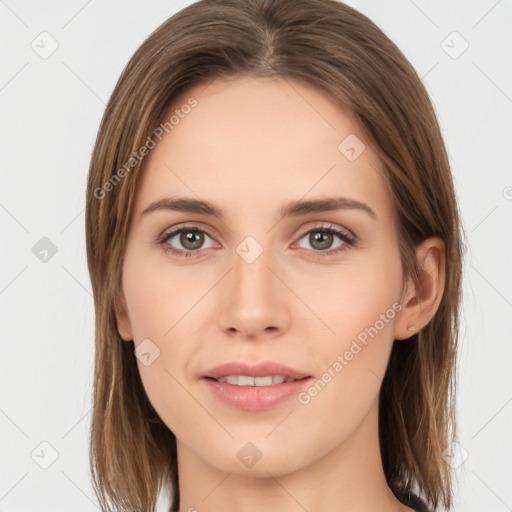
118, 78, 412, 476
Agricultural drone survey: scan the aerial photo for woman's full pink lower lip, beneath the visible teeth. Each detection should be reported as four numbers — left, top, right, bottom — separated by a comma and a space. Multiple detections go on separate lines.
203, 377, 311, 411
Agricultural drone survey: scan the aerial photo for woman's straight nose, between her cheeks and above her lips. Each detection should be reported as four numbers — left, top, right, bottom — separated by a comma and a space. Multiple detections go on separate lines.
218, 242, 292, 340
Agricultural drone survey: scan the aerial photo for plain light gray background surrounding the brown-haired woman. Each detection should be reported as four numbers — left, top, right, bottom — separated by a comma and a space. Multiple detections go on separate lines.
0, 0, 512, 512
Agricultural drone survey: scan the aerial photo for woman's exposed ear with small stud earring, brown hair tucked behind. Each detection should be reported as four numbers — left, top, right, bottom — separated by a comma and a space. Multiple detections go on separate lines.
395, 237, 445, 340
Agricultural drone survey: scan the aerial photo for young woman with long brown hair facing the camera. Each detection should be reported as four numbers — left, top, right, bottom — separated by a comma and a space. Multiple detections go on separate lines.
86, 0, 461, 511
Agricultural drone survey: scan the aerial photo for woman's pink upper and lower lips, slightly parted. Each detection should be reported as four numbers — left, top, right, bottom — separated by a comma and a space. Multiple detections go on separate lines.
201, 362, 311, 412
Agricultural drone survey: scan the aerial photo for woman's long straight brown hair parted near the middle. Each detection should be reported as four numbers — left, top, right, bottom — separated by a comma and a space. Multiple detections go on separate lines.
86, 0, 462, 512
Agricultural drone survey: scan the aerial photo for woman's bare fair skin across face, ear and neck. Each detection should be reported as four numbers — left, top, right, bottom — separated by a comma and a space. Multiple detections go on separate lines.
117, 78, 444, 512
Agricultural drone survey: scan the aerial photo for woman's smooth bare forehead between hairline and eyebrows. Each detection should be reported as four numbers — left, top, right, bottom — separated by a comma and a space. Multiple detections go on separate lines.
132, 78, 390, 222
